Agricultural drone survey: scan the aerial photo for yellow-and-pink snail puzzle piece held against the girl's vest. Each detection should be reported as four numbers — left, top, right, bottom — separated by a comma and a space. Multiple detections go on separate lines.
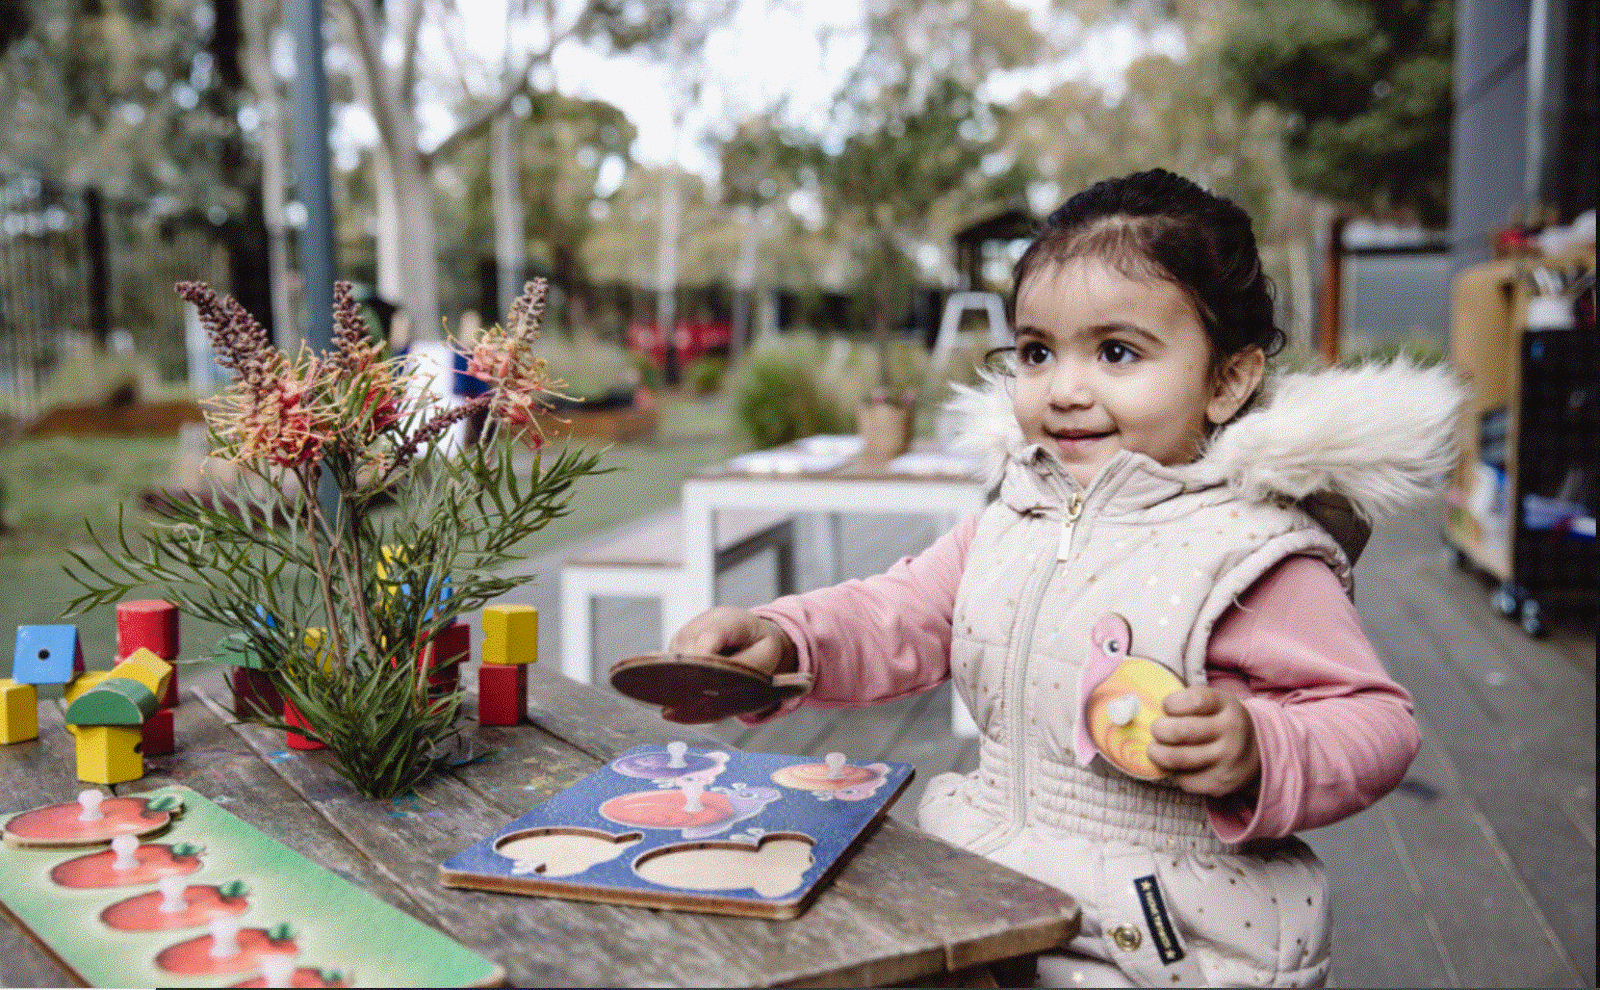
1077, 613, 1184, 780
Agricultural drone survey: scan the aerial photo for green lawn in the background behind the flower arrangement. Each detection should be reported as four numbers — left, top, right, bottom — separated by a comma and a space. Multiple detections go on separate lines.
0, 398, 747, 673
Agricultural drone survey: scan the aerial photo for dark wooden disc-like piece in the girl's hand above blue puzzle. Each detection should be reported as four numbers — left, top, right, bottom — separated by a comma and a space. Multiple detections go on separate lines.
611, 653, 813, 725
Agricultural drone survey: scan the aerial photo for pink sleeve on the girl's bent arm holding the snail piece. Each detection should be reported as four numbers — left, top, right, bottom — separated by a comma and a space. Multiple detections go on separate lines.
1206, 557, 1419, 843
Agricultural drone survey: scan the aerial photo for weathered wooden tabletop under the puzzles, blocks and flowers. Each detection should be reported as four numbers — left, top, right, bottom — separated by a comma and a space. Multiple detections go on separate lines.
0, 667, 1078, 987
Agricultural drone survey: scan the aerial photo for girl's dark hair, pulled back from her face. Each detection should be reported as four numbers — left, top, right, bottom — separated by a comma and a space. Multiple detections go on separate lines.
1011, 168, 1288, 363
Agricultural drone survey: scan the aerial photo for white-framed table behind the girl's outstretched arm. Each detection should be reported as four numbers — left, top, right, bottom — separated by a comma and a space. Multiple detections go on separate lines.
675, 437, 989, 737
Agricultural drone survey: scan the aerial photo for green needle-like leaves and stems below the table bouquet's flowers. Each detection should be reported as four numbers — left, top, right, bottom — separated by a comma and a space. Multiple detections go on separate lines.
66, 445, 598, 796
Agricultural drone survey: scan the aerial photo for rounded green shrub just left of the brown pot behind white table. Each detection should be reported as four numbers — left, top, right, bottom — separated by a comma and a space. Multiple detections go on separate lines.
730, 334, 853, 448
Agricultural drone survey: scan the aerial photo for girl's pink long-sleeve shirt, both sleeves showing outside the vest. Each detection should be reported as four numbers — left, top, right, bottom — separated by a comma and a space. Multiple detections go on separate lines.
755, 515, 1419, 843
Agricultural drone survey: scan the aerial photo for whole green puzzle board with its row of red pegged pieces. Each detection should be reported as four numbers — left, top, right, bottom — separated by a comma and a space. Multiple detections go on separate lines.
0, 785, 504, 987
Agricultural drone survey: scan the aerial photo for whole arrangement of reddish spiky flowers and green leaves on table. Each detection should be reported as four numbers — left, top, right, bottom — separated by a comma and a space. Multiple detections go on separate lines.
66, 280, 602, 796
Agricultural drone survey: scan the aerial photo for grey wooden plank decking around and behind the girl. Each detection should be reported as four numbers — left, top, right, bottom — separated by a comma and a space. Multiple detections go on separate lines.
492, 510, 1595, 987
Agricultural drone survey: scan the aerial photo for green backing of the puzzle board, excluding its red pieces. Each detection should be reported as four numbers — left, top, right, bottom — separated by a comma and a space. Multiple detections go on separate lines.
0, 787, 504, 987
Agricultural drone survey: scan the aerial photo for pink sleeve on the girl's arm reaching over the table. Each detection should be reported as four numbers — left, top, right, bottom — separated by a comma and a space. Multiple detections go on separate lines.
750, 515, 978, 721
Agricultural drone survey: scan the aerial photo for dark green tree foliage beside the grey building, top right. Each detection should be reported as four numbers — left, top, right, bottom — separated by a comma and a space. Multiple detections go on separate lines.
1219, 0, 1454, 227
